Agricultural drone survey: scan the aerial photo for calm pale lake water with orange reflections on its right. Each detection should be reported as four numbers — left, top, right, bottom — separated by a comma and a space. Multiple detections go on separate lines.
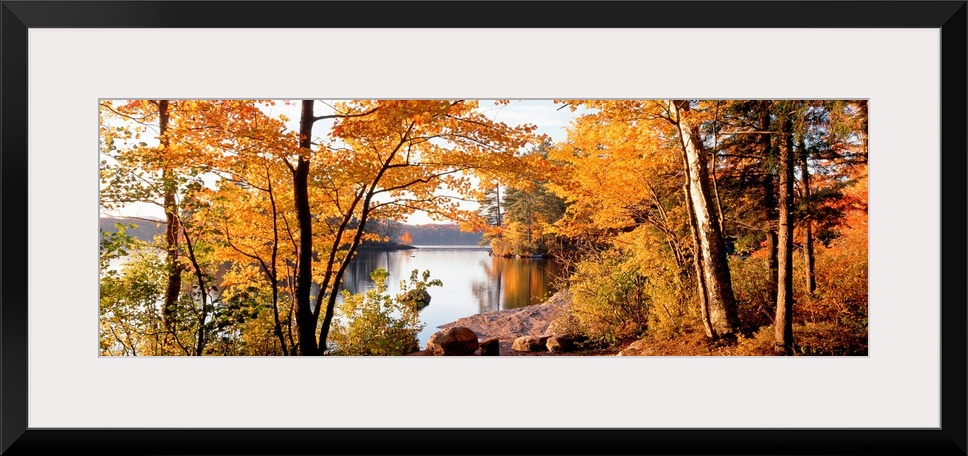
343, 246, 560, 347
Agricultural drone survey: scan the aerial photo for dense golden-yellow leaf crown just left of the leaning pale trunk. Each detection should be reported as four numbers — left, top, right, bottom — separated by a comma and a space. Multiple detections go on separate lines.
549, 100, 681, 242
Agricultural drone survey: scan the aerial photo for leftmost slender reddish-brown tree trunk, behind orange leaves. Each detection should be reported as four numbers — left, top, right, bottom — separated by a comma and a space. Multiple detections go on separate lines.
158, 100, 182, 337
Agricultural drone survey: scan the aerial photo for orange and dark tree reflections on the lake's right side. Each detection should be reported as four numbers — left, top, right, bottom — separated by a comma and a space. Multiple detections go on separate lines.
472, 257, 561, 312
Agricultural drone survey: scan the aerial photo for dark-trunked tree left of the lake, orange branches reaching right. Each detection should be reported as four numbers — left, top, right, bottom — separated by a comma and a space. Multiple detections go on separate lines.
286, 100, 533, 355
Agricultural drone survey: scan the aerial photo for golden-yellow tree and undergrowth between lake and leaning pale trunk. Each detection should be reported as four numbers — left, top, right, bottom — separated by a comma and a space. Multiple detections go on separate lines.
550, 100, 701, 338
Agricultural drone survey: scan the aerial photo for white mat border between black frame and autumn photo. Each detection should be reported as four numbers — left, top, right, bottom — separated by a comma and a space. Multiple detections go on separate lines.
28, 28, 941, 428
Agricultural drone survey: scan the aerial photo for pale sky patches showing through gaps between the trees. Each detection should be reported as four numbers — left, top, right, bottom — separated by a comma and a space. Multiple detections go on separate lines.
101, 100, 580, 225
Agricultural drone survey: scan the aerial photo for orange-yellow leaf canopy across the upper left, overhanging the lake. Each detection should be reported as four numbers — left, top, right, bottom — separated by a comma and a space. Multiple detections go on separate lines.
101, 100, 555, 284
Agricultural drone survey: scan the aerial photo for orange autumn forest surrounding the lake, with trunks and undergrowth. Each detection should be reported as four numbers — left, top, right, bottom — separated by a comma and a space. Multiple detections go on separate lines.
99, 99, 868, 356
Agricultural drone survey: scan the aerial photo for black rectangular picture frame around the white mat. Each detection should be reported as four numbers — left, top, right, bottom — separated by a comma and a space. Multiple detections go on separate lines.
0, 0, 968, 455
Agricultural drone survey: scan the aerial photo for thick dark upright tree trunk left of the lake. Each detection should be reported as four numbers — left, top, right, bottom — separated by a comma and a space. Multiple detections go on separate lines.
292, 100, 322, 356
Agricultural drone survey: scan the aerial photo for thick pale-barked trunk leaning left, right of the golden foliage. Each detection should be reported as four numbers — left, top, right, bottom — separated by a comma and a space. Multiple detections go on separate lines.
668, 100, 739, 339
